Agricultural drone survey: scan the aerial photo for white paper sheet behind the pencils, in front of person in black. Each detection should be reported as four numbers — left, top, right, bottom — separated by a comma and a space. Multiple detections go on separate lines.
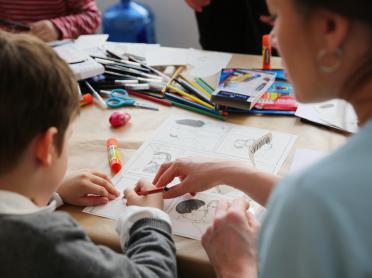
187, 49, 232, 78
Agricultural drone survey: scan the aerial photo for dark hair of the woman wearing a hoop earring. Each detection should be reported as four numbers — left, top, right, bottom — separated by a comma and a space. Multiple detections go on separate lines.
294, 0, 372, 92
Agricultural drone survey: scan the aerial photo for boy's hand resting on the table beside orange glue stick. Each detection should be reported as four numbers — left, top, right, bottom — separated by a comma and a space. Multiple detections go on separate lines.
57, 170, 120, 206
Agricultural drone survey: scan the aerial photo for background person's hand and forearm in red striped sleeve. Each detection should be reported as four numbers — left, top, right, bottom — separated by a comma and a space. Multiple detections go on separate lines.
31, 0, 101, 41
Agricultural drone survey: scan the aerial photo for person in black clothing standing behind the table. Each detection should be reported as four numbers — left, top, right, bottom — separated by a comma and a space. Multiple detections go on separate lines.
185, 0, 271, 54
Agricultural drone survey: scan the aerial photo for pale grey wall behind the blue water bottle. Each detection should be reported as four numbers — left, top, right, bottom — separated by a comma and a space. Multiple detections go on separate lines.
97, 0, 200, 48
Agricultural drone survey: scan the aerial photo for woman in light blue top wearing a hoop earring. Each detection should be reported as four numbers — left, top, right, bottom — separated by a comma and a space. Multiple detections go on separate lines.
141, 0, 372, 278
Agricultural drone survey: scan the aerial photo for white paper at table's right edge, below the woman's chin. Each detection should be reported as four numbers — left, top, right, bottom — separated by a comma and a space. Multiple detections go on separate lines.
295, 99, 358, 133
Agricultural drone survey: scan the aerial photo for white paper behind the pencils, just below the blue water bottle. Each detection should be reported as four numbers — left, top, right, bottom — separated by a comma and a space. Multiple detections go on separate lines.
146, 47, 187, 67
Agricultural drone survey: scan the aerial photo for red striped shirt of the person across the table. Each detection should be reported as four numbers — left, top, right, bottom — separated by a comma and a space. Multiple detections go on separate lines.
0, 0, 101, 39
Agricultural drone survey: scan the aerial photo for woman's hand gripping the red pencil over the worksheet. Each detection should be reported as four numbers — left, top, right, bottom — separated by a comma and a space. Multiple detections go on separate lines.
152, 158, 231, 199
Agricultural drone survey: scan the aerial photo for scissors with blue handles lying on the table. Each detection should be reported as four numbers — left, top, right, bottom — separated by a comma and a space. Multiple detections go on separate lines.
106, 89, 159, 111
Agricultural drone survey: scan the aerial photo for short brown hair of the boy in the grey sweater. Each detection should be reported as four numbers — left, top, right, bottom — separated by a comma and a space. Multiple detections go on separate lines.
0, 31, 79, 175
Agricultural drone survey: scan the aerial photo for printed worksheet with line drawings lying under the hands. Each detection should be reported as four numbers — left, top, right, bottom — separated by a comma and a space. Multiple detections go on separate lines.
83, 115, 296, 239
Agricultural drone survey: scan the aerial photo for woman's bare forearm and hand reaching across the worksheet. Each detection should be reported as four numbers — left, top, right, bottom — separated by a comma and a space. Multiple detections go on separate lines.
153, 158, 279, 206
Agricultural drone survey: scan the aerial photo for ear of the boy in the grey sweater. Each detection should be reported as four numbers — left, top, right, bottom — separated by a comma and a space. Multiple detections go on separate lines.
35, 127, 58, 166
